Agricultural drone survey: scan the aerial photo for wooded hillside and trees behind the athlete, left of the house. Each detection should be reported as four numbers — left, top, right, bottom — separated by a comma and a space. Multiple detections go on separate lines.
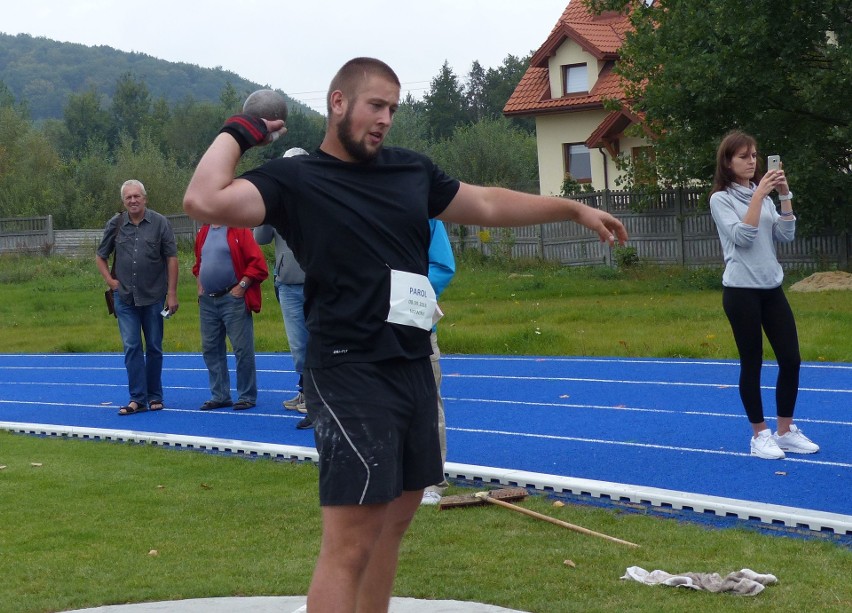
0, 35, 538, 229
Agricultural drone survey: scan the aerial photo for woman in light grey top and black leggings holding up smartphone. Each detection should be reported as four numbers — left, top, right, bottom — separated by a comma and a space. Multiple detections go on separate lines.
710, 131, 819, 459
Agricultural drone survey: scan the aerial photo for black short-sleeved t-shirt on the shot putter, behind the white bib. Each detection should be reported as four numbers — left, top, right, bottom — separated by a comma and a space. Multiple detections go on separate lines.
242, 147, 459, 368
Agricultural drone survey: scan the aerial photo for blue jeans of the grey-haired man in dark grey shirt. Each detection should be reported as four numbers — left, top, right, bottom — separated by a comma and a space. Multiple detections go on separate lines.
114, 292, 165, 406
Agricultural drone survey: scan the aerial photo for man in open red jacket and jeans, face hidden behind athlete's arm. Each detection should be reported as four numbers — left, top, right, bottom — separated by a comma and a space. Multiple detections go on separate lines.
192, 224, 269, 411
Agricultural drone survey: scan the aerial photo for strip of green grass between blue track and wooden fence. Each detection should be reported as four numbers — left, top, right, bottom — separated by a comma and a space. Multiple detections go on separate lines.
0, 252, 852, 362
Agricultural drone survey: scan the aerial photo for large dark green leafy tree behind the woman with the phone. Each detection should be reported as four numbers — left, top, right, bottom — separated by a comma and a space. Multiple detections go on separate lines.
592, 0, 852, 231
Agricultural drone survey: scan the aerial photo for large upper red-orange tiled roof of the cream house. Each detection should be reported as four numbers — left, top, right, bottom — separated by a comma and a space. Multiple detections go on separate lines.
503, 0, 630, 115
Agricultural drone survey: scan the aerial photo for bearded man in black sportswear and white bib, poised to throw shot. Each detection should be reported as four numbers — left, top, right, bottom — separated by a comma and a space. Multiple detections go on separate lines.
184, 58, 627, 613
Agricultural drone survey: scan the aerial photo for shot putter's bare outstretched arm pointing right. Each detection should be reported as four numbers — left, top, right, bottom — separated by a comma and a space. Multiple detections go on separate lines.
438, 183, 627, 245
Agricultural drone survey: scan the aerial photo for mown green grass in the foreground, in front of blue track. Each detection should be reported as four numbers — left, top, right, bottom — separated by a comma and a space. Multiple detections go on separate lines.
0, 432, 852, 613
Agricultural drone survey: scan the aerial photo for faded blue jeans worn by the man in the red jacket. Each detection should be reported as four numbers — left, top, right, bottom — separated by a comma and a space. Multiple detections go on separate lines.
198, 293, 257, 404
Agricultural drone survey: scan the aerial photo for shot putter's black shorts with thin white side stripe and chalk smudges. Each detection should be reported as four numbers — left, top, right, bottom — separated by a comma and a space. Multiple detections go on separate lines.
304, 357, 444, 506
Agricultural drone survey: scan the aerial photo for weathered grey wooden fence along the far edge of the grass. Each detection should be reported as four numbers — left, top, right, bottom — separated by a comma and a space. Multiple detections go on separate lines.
0, 189, 852, 270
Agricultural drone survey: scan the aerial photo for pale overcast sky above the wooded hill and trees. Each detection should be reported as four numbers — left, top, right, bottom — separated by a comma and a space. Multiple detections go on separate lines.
5, 0, 568, 113
